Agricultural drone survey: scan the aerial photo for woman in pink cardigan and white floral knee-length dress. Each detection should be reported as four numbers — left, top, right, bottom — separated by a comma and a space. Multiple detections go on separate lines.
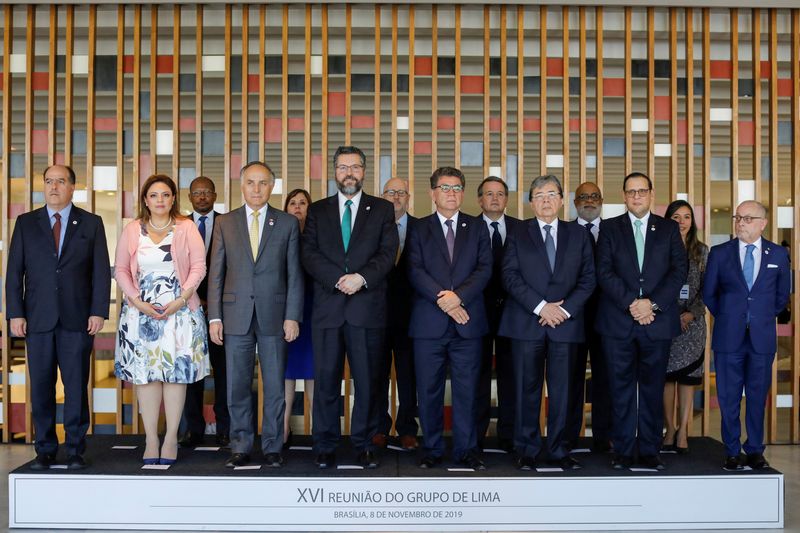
114, 174, 210, 465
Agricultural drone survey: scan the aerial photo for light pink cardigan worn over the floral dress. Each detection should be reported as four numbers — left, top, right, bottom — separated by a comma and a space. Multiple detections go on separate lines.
114, 215, 206, 311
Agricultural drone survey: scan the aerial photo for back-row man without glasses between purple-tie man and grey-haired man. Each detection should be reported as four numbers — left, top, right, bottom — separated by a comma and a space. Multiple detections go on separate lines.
476, 176, 520, 452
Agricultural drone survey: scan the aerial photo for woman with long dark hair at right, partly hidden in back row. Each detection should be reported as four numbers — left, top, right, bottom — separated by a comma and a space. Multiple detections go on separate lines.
664, 200, 708, 453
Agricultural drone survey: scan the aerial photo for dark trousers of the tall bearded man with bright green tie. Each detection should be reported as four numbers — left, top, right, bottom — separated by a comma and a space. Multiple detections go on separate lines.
311, 323, 385, 454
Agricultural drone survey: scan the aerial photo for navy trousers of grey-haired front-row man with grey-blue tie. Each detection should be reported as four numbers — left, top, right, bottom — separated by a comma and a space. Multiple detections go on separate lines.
511, 339, 577, 460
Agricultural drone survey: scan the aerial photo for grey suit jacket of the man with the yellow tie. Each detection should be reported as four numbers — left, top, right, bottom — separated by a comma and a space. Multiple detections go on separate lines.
207, 206, 304, 336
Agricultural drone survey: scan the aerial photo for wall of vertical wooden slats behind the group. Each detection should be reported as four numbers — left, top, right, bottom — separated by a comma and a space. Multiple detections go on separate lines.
0, 4, 800, 442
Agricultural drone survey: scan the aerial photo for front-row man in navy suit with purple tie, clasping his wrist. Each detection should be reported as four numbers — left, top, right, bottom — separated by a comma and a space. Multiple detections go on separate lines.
406, 167, 492, 470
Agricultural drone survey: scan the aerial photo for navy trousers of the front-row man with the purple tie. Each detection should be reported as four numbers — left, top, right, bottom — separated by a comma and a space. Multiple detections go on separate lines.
414, 321, 481, 460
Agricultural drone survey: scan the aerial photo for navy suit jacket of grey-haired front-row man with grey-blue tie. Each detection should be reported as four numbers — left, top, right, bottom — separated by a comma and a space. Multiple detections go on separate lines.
499, 218, 596, 342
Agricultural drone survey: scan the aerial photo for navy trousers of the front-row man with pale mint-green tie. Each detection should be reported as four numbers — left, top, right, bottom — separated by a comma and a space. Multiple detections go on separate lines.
603, 324, 671, 457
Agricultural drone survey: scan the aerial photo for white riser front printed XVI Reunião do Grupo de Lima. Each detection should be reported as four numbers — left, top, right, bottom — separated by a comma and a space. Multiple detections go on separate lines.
9, 474, 784, 531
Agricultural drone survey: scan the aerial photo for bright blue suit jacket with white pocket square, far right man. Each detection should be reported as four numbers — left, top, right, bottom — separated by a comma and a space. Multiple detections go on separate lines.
703, 238, 791, 353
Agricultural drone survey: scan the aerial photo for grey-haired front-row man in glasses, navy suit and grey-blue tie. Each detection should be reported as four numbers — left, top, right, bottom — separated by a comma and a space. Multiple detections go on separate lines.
499, 175, 596, 470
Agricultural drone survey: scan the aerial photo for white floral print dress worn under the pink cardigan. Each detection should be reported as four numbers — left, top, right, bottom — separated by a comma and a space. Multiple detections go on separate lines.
114, 228, 210, 385
